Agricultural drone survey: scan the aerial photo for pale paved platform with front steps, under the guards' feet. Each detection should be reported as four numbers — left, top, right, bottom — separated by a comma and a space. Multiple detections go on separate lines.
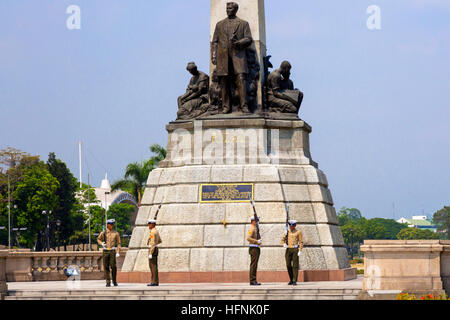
7, 277, 362, 300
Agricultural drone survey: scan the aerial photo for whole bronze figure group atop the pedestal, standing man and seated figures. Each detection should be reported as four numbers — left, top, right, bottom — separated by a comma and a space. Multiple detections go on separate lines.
177, 2, 303, 120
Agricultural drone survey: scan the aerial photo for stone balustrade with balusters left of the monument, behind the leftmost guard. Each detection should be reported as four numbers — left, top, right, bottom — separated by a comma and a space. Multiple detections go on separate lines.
6, 249, 127, 282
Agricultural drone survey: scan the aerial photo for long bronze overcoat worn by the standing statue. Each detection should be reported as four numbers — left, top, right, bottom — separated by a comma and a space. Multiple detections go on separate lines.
212, 17, 253, 77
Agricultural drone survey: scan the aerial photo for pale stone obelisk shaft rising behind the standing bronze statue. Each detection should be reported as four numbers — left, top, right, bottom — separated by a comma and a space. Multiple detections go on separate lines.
210, 0, 267, 111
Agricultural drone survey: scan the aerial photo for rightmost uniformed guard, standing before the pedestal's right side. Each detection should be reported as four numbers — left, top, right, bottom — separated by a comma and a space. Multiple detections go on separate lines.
281, 220, 303, 286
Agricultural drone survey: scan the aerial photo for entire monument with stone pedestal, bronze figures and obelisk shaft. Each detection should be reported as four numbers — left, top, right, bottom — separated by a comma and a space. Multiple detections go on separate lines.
119, 0, 356, 283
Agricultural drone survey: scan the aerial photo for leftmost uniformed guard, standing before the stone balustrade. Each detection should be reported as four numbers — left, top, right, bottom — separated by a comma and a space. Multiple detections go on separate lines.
97, 219, 121, 287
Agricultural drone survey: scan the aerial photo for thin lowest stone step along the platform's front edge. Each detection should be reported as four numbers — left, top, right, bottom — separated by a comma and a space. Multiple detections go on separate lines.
6, 293, 358, 301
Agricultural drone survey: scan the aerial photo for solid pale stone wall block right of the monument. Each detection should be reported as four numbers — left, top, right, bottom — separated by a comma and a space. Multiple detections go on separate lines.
361, 240, 450, 298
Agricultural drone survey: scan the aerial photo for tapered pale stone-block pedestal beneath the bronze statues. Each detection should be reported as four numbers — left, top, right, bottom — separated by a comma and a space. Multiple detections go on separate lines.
121, 118, 356, 282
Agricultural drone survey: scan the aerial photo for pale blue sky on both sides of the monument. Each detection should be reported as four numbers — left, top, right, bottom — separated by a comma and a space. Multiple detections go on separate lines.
0, 0, 450, 218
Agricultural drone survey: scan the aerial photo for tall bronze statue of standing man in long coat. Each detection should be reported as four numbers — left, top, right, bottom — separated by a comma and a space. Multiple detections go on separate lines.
212, 2, 253, 113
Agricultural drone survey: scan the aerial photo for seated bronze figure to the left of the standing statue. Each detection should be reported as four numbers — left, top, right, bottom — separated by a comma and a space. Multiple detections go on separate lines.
178, 62, 209, 120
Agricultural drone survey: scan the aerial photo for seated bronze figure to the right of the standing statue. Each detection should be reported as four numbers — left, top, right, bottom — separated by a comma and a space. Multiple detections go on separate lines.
267, 61, 303, 114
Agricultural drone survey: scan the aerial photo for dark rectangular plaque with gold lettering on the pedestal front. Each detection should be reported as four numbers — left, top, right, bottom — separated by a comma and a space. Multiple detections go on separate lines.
200, 184, 253, 203
